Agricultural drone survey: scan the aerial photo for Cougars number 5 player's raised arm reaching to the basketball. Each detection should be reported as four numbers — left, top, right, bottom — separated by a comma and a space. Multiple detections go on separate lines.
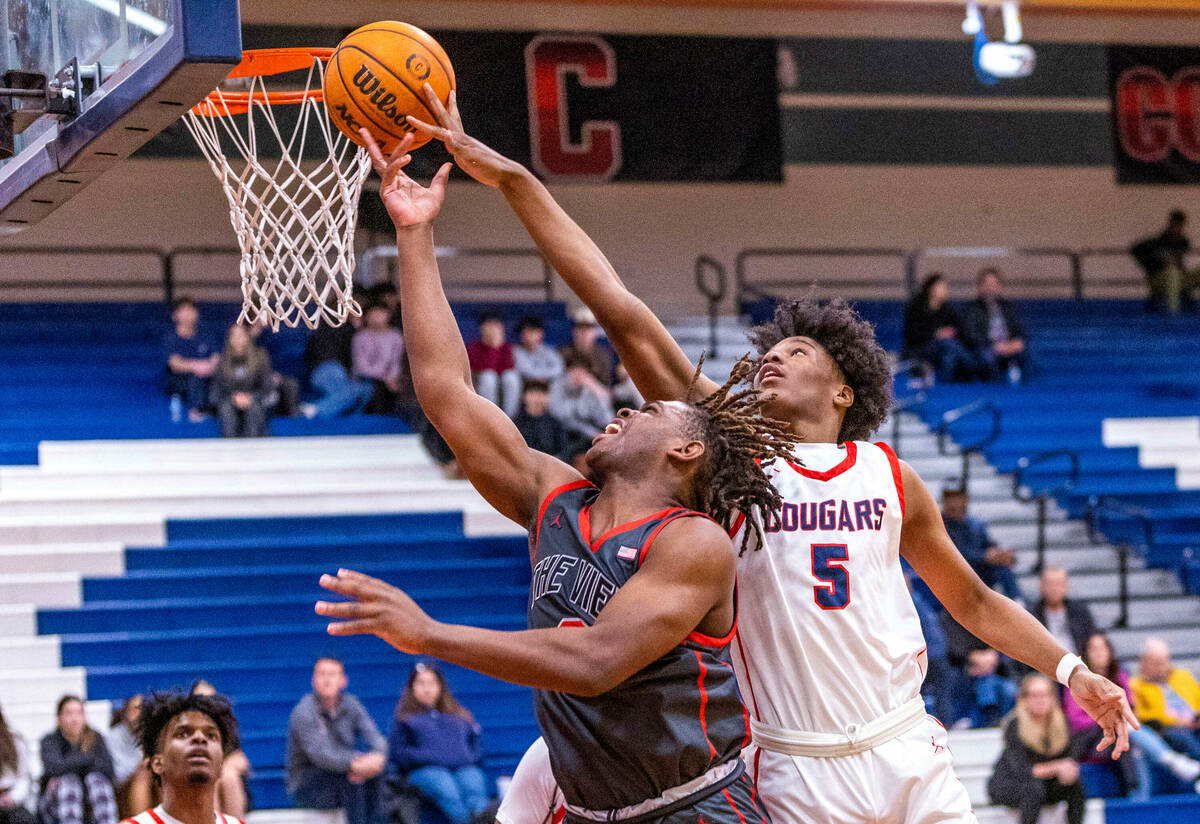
408, 84, 716, 402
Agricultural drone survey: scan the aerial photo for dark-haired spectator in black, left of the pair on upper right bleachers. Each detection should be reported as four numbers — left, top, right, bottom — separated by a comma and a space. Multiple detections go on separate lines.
904, 273, 979, 381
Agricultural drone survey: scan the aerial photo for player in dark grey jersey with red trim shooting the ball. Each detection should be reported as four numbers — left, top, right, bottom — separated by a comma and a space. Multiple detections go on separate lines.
317, 131, 790, 824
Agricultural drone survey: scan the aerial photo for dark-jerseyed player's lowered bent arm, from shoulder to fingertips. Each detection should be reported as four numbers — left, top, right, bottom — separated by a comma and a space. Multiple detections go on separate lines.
317, 518, 736, 696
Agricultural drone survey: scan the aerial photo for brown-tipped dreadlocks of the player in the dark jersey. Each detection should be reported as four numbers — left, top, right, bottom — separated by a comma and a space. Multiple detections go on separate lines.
685, 355, 796, 555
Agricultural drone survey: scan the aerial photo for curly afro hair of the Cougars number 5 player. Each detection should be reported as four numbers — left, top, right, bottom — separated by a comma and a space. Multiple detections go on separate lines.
749, 297, 892, 441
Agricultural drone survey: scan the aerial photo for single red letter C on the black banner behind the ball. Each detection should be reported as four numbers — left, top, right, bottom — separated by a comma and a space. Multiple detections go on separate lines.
526, 35, 620, 180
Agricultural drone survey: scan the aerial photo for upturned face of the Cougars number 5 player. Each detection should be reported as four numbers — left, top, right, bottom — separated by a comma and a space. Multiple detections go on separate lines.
754, 335, 853, 429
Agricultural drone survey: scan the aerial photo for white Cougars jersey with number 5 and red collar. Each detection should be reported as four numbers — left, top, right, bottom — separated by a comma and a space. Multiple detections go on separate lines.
733, 441, 926, 734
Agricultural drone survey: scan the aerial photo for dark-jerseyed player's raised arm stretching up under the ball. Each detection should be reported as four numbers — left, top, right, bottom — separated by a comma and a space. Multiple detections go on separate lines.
364, 134, 580, 527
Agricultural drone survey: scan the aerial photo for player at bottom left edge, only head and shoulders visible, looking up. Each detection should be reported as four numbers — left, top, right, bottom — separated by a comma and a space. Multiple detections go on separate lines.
122, 691, 244, 824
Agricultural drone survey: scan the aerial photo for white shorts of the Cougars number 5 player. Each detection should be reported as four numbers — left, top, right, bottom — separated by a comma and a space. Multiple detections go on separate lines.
743, 717, 977, 824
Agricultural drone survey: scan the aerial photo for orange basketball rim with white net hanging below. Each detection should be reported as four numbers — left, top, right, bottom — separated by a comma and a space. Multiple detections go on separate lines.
184, 48, 371, 331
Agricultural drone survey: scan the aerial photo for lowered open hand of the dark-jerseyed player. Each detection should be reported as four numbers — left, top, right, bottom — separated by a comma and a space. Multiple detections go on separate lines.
317, 570, 433, 655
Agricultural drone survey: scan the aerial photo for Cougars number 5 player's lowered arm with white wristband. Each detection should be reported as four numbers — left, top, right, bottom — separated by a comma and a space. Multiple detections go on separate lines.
900, 461, 1139, 758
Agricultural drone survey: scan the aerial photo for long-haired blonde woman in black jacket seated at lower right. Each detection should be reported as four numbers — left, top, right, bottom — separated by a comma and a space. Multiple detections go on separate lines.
988, 673, 1087, 824
